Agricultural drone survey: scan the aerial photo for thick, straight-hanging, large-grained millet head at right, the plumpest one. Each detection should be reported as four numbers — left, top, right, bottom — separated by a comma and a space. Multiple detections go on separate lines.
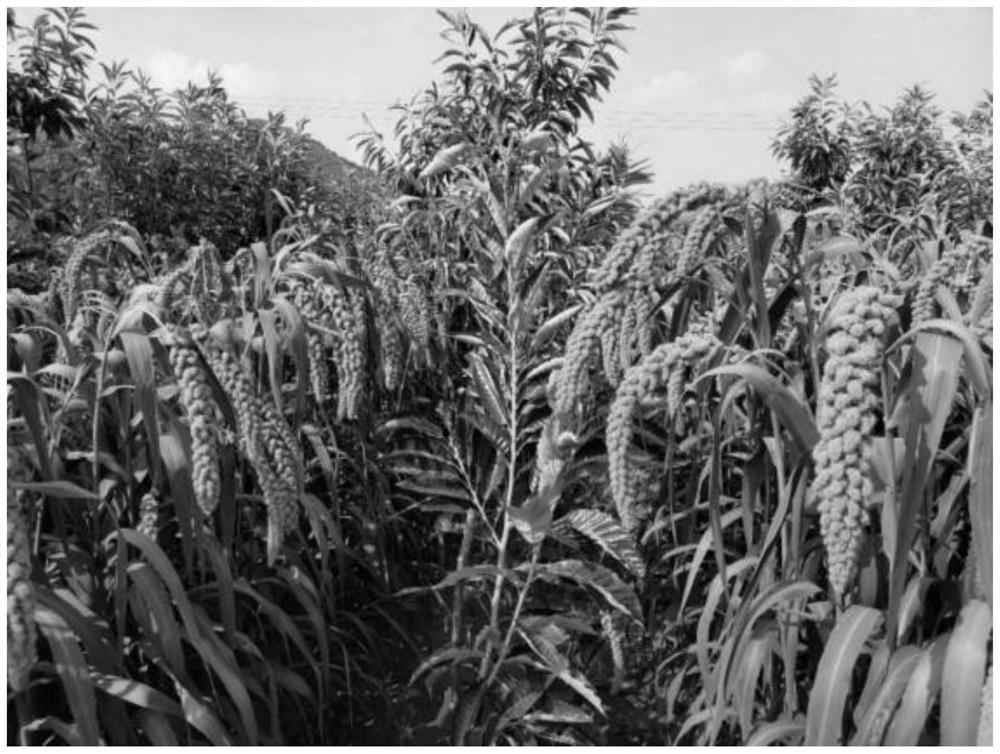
809, 286, 900, 604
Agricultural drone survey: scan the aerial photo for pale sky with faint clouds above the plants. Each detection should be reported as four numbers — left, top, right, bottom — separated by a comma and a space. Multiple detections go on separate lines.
7, 7, 993, 195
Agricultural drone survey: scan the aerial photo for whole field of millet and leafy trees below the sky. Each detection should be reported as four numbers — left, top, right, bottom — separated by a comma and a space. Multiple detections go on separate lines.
6, 9, 993, 745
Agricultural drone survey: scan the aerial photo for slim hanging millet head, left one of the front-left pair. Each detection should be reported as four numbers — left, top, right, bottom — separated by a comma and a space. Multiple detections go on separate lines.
164, 325, 221, 516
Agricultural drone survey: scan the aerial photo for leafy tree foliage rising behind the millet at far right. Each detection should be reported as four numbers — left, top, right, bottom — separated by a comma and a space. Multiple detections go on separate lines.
772, 76, 993, 245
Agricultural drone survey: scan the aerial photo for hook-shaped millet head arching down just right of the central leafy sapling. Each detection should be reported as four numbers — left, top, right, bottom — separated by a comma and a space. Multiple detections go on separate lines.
606, 332, 720, 531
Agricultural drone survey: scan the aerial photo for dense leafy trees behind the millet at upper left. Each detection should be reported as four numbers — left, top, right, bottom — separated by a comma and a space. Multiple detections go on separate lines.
8, 10, 380, 265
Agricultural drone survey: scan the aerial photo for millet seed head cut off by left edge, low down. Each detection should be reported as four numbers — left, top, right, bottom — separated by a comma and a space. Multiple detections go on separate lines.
7, 476, 37, 692
